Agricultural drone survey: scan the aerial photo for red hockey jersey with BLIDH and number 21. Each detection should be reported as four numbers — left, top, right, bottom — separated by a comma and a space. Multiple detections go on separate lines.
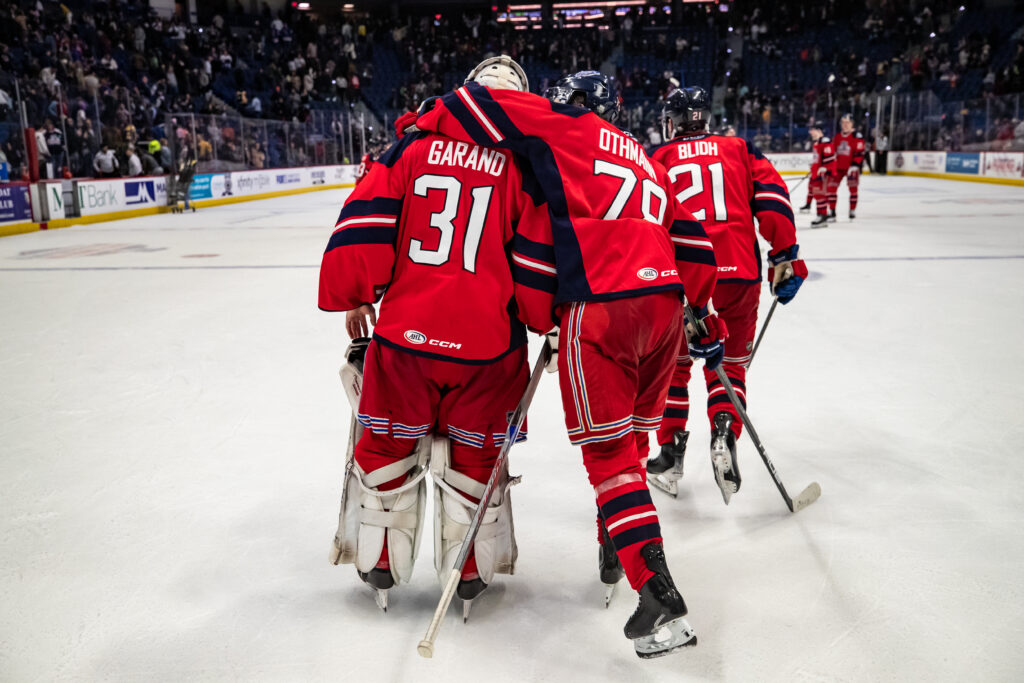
652, 134, 797, 283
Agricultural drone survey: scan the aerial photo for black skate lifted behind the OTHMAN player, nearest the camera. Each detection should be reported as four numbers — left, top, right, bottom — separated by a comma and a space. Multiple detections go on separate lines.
624, 543, 697, 659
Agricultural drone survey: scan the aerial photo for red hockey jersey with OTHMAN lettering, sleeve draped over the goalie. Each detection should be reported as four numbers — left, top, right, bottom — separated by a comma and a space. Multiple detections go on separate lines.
416, 83, 716, 306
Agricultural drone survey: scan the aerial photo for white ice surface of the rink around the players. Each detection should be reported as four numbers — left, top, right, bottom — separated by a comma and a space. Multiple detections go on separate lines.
0, 176, 1024, 683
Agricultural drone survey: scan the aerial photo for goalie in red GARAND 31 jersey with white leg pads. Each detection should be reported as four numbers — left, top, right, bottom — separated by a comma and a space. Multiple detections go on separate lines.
319, 56, 555, 613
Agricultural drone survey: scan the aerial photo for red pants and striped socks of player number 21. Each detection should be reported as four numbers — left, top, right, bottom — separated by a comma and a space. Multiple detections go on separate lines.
657, 282, 761, 443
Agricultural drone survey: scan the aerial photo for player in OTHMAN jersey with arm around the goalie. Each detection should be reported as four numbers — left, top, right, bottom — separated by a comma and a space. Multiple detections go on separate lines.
399, 72, 725, 657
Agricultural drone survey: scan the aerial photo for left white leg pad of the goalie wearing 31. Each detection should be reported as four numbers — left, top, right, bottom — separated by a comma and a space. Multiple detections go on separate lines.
331, 436, 430, 584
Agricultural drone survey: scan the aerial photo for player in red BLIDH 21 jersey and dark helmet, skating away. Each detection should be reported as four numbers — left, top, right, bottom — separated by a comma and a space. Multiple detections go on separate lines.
647, 87, 807, 504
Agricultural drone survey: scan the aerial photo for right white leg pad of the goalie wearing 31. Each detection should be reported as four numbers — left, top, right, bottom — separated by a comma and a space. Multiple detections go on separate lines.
430, 438, 519, 584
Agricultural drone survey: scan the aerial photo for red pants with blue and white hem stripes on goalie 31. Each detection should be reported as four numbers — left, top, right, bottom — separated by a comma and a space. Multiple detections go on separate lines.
354, 341, 528, 583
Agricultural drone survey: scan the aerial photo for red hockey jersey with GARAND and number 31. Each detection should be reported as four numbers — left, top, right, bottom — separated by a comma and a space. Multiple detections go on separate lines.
319, 133, 555, 364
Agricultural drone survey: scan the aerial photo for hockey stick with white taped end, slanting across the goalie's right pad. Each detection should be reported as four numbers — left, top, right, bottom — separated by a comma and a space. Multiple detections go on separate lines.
416, 341, 551, 658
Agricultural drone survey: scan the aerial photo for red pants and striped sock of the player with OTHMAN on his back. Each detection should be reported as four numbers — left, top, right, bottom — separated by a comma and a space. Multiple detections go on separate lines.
558, 293, 683, 591
